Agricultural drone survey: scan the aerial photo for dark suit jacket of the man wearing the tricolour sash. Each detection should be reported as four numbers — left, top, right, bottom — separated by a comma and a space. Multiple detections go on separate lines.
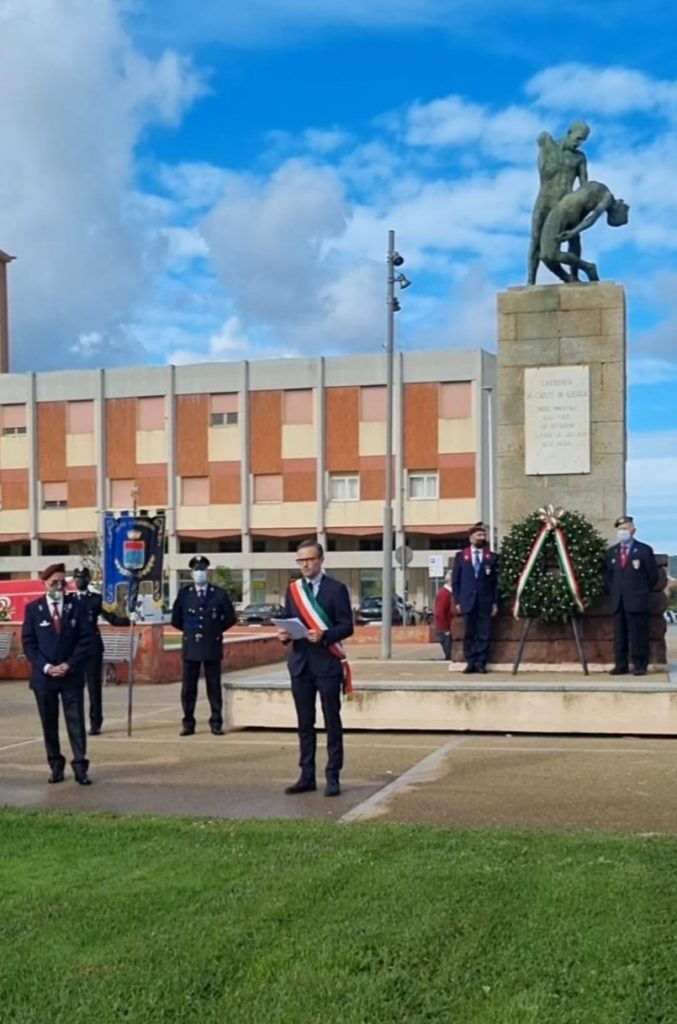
285, 575, 354, 676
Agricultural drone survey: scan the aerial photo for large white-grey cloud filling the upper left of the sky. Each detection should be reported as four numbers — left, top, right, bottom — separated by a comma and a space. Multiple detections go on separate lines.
0, 0, 202, 369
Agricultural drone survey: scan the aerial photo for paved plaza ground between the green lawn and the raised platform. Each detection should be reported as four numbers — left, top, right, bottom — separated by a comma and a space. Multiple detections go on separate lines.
0, 631, 677, 835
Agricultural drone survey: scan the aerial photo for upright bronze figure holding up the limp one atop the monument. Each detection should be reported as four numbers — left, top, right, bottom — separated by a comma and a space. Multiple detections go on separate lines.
527, 121, 590, 285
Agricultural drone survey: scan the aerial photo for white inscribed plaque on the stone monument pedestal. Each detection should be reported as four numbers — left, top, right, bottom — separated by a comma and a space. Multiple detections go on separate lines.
524, 367, 590, 476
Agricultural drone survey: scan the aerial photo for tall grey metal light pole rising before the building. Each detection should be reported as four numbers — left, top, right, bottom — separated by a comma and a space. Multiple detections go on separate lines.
381, 231, 395, 660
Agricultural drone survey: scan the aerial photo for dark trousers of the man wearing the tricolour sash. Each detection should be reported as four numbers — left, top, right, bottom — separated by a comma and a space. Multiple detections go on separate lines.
292, 672, 343, 782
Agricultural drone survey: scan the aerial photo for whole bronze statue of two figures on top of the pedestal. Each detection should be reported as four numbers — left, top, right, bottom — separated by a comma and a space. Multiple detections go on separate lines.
527, 121, 630, 285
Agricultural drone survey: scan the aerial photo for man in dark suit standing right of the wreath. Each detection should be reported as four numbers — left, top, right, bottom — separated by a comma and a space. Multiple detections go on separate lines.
606, 515, 659, 676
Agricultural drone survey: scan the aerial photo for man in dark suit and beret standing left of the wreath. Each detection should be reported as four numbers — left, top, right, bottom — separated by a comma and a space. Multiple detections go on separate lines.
452, 522, 499, 673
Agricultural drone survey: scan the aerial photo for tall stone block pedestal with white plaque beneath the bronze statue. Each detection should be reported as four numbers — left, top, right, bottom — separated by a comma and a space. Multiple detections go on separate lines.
497, 282, 627, 539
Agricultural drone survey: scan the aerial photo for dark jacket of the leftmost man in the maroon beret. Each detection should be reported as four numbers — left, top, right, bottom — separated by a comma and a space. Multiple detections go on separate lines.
22, 594, 91, 692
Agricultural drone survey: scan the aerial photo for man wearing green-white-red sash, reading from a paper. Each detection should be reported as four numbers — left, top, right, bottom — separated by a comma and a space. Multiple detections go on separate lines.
278, 541, 353, 797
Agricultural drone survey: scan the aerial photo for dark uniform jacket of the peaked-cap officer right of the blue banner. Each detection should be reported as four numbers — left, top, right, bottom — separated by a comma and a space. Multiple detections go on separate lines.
172, 583, 236, 662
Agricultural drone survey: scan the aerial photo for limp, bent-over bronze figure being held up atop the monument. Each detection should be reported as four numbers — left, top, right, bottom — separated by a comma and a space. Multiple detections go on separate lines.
540, 181, 630, 282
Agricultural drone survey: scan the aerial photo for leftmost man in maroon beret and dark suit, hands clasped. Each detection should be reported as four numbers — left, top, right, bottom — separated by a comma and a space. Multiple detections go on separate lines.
22, 562, 91, 785
